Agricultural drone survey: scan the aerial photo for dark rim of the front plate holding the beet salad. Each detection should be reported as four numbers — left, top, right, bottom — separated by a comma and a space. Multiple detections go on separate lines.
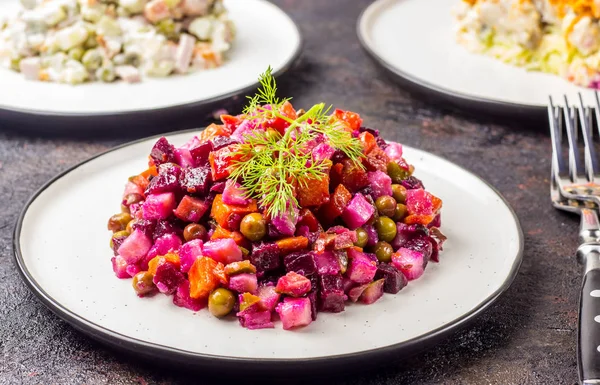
12, 128, 524, 373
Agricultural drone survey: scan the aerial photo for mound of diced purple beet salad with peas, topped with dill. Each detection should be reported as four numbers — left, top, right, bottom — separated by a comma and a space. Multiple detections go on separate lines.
108, 69, 445, 329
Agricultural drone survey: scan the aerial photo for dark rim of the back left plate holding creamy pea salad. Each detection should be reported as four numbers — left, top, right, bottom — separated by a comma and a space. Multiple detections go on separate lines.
0, 0, 306, 118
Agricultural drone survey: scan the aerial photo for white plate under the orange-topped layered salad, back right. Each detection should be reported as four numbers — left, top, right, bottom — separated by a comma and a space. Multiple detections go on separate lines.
357, 0, 595, 115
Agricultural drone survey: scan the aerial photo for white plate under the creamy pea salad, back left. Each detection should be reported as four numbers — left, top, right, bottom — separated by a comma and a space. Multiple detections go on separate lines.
0, 0, 301, 127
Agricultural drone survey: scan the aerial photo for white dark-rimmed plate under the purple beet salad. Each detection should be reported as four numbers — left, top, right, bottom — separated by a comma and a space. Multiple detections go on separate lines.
14, 131, 523, 373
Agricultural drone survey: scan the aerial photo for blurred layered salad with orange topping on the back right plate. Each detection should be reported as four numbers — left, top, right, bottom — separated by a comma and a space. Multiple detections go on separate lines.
455, 0, 600, 88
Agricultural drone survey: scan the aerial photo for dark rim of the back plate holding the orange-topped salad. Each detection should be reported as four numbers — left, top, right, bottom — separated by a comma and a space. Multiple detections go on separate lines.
356, 0, 547, 117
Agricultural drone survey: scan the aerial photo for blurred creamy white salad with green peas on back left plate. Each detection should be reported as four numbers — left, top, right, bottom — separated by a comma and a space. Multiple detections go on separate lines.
0, 0, 235, 84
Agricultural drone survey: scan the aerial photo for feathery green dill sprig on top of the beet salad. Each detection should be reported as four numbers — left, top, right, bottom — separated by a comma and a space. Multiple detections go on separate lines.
231, 67, 364, 218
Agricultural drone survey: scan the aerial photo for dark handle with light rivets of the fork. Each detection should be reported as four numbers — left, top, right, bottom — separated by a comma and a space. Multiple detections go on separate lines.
577, 258, 600, 385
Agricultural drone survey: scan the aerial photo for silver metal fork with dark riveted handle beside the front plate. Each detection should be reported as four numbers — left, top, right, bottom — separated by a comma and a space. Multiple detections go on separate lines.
548, 94, 600, 385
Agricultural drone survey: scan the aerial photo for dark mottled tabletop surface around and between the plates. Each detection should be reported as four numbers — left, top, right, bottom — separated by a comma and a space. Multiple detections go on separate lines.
0, 0, 580, 385
